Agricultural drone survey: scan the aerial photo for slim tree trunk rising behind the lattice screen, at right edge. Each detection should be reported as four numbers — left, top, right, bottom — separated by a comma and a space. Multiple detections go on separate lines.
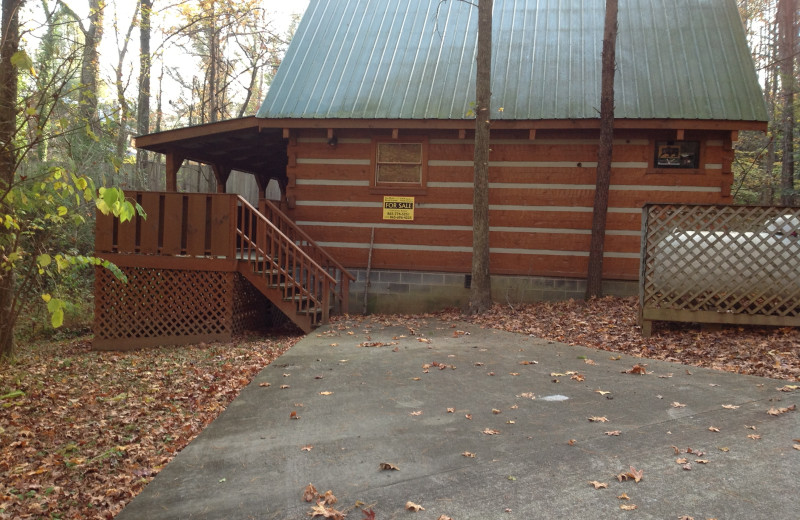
777, 0, 796, 206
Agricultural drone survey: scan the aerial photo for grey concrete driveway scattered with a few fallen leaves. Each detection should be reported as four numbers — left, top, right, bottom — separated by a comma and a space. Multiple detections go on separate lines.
117, 320, 800, 520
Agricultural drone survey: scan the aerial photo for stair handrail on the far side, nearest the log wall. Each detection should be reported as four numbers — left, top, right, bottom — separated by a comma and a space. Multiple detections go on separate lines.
259, 200, 355, 312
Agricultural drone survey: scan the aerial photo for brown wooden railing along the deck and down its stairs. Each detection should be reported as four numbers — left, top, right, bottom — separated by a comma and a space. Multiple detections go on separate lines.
95, 192, 346, 325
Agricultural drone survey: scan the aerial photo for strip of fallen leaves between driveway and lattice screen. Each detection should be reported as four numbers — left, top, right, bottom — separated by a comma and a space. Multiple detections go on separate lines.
438, 296, 800, 381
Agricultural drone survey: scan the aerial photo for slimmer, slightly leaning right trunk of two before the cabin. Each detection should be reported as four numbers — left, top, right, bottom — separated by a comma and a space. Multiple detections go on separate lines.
586, 0, 617, 300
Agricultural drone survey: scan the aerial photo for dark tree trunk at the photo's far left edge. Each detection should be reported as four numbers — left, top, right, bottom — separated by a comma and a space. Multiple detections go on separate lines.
0, 0, 25, 359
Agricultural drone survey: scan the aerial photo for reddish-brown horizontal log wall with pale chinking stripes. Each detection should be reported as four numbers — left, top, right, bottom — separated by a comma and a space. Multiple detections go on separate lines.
286, 130, 732, 280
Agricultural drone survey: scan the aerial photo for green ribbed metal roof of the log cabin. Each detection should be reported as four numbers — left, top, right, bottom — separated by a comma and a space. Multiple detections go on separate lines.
257, 0, 767, 121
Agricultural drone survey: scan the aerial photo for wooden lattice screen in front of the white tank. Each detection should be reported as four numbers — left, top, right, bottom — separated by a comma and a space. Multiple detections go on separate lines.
639, 204, 800, 335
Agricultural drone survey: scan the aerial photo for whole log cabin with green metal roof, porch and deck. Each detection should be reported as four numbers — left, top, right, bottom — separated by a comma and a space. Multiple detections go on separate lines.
95, 0, 767, 348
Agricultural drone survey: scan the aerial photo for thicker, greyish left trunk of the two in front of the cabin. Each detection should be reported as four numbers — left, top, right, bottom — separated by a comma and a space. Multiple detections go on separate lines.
469, 0, 493, 314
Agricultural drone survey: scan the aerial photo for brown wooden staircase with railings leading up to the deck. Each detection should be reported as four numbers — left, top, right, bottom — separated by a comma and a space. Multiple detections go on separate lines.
236, 197, 354, 333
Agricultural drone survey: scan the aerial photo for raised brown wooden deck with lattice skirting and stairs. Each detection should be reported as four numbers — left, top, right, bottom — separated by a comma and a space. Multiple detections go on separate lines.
94, 192, 353, 349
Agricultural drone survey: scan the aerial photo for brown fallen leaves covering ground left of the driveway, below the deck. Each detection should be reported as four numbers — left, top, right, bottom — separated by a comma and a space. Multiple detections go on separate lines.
0, 335, 300, 518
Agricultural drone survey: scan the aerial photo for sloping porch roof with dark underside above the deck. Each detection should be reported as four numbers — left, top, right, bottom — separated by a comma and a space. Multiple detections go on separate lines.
134, 116, 286, 174
